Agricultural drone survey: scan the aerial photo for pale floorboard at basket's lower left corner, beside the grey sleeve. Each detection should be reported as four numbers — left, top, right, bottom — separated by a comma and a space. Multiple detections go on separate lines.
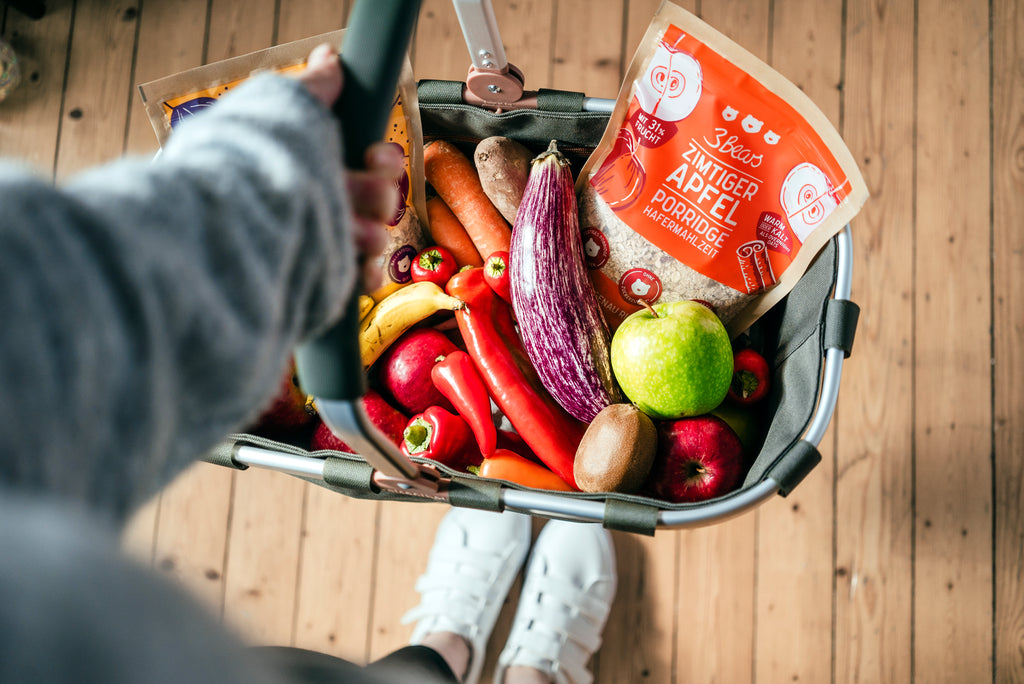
154, 463, 234, 615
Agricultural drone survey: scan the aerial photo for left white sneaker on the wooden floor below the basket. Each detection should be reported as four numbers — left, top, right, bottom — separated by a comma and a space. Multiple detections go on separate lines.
401, 508, 531, 684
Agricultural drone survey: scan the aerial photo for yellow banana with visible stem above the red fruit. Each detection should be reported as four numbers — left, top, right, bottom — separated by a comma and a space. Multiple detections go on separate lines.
359, 281, 464, 369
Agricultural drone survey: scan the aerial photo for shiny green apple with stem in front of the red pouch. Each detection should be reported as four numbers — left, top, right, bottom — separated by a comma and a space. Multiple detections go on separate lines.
611, 301, 732, 420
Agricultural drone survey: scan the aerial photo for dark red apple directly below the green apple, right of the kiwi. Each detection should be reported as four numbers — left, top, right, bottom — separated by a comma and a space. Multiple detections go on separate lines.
646, 415, 743, 504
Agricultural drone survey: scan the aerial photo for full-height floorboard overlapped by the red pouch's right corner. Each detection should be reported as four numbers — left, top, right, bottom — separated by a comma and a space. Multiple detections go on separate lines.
834, 2, 914, 684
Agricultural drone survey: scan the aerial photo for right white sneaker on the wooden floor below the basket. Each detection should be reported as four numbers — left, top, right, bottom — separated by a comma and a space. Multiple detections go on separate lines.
495, 520, 617, 684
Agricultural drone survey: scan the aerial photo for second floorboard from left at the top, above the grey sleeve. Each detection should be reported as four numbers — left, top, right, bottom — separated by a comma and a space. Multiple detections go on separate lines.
56, 0, 138, 180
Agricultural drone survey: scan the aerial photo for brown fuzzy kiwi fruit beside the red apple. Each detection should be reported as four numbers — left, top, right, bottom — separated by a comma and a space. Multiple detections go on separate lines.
572, 403, 657, 494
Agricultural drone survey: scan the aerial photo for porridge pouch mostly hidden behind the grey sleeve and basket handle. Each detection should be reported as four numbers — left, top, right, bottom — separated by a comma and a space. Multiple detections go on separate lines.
138, 31, 429, 292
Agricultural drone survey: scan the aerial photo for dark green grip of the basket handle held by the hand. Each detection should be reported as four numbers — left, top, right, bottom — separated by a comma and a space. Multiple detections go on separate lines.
296, 0, 420, 400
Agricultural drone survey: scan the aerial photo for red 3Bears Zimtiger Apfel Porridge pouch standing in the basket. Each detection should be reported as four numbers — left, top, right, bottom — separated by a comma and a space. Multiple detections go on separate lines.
577, 2, 867, 337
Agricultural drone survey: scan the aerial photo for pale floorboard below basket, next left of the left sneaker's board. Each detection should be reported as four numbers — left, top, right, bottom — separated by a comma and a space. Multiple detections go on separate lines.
294, 484, 381, 662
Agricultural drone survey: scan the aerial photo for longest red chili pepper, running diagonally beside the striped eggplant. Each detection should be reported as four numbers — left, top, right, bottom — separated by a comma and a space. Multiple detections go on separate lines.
447, 267, 586, 487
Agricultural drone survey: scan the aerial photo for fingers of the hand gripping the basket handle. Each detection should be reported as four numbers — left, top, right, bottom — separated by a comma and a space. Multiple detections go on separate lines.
298, 44, 404, 291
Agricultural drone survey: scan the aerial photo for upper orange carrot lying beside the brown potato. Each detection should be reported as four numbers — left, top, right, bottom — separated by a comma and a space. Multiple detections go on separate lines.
423, 140, 512, 257
